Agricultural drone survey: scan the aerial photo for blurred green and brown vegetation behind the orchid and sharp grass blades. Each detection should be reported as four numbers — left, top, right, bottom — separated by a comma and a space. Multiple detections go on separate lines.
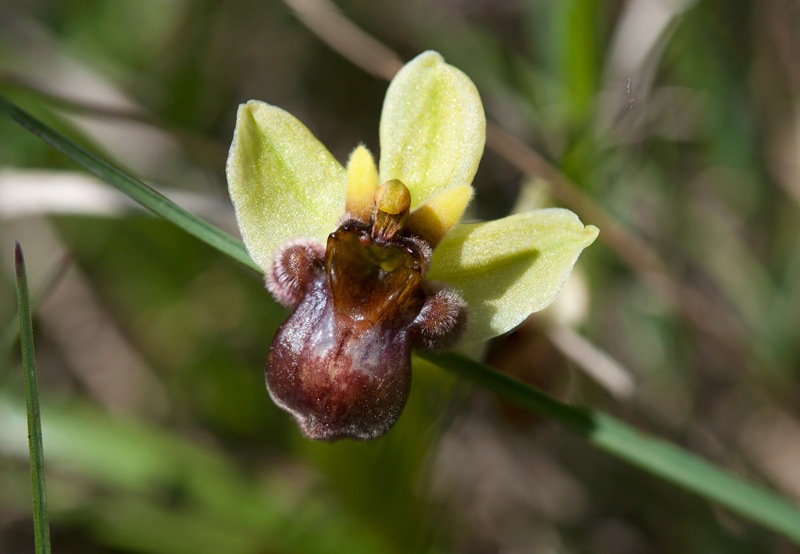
0, 0, 800, 554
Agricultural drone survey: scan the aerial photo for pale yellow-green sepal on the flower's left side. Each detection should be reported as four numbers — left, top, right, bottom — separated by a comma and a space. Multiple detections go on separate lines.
226, 100, 345, 273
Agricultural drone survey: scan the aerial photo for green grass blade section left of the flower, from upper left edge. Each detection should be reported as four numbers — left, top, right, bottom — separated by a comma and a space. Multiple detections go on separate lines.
0, 96, 260, 271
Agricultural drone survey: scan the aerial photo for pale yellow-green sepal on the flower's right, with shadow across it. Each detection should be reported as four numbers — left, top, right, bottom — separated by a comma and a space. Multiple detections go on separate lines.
429, 208, 598, 342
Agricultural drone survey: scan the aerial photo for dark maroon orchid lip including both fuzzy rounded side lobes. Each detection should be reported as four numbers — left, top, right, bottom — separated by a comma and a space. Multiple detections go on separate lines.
266, 190, 465, 441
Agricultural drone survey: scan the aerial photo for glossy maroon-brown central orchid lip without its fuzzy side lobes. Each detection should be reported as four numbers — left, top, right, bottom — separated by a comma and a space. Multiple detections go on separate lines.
266, 222, 424, 441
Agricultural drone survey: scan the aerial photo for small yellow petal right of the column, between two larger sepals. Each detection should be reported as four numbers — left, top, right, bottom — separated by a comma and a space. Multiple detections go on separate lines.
408, 185, 473, 248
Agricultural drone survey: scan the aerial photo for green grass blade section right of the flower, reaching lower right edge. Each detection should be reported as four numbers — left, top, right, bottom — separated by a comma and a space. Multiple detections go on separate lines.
418, 352, 800, 544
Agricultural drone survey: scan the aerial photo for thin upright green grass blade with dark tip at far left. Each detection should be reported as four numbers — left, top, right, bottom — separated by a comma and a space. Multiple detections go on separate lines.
14, 243, 50, 554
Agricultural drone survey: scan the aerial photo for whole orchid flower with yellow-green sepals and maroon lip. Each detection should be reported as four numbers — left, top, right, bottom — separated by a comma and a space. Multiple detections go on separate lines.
227, 52, 598, 440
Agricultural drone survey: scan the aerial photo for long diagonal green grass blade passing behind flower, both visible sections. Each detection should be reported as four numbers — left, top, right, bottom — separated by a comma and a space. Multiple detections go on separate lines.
6, 98, 800, 544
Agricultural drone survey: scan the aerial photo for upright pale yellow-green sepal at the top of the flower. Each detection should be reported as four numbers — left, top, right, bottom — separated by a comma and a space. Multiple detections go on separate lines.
379, 52, 486, 209
